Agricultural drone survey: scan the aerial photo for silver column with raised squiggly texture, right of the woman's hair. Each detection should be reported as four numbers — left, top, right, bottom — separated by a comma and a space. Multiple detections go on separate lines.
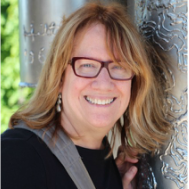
128, 0, 188, 189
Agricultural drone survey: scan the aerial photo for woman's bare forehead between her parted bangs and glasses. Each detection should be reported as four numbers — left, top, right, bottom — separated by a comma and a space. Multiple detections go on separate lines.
72, 23, 119, 61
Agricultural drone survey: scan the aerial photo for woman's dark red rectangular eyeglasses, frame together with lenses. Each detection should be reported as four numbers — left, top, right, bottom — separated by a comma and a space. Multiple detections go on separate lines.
70, 57, 134, 81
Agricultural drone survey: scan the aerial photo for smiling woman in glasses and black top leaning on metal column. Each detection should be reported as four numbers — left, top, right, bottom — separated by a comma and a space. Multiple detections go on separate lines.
0, 3, 169, 189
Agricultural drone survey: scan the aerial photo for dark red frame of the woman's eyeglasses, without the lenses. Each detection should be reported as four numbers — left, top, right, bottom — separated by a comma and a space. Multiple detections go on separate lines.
69, 57, 135, 81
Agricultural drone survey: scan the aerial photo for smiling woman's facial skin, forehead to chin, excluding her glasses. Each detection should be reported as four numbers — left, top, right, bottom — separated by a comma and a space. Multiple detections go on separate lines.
62, 24, 131, 132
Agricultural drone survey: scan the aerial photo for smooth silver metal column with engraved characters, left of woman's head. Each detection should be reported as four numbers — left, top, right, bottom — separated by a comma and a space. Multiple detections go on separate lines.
19, 0, 87, 87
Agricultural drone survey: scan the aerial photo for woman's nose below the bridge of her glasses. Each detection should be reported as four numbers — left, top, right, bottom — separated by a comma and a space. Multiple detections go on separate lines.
92, 68, 115, 91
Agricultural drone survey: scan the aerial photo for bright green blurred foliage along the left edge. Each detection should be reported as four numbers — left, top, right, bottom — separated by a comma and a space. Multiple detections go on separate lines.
0, 0, 31, 133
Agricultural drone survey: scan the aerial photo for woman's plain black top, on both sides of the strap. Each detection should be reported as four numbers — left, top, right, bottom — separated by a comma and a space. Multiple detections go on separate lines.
0, 129, 123, 189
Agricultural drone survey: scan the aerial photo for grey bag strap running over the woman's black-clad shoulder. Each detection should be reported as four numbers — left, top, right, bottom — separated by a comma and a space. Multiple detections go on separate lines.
15, 122, 95, 189
